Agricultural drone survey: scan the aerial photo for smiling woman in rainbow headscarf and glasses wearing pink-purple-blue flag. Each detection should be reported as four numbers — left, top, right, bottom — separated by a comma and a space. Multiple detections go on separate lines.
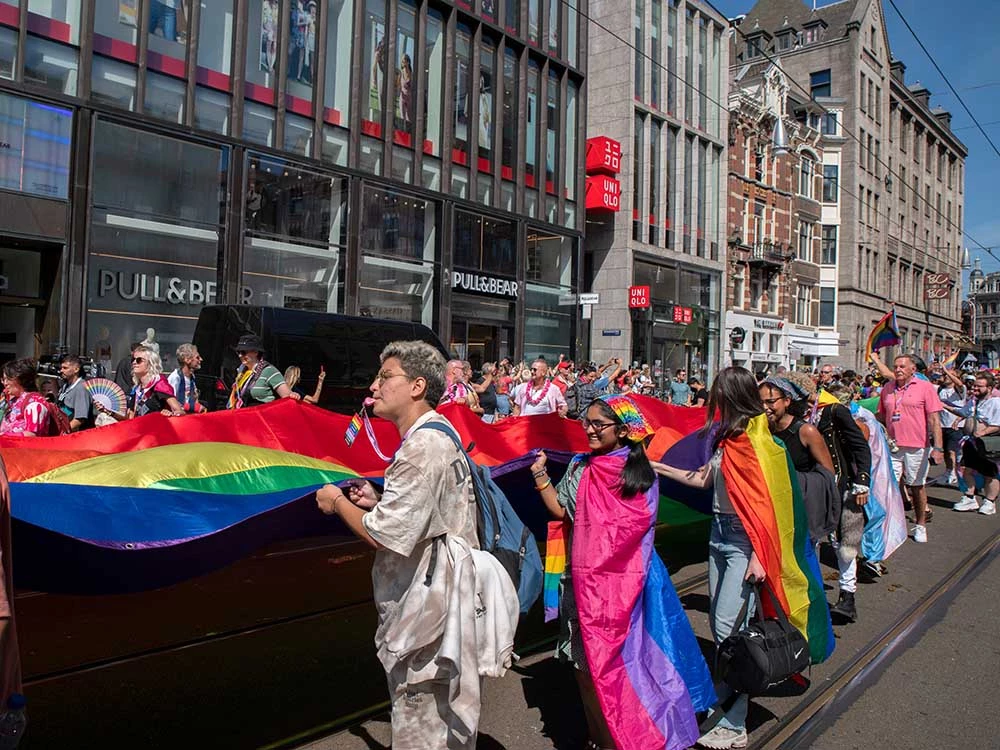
531, 394, 715, 750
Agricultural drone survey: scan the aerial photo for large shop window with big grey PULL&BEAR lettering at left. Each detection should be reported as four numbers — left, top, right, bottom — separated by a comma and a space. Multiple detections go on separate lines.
86, 119, 228, 371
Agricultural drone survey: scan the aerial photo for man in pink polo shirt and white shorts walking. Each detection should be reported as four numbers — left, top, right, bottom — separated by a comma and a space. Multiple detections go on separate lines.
878, 354, 944, 543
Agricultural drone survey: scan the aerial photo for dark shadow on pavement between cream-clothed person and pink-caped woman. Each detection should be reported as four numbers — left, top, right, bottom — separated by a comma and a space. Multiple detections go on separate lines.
516, 659, 587, 750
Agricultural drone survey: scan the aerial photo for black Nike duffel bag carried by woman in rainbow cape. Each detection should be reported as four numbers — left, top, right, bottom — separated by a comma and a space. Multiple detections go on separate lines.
716, 581, 809, 696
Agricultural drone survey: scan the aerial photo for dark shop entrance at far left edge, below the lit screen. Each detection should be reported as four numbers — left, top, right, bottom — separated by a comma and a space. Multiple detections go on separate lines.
0, 244, 59, 362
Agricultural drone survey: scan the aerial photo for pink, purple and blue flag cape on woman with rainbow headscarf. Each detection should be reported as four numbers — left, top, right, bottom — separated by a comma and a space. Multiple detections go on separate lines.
570, 448, 716, 750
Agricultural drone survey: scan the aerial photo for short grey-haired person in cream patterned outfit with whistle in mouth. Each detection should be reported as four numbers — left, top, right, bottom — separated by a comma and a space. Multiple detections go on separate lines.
316, 341, 480, 750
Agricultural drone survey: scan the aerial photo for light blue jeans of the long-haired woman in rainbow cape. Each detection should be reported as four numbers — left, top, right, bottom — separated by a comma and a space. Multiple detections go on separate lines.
708, 513, 754, 730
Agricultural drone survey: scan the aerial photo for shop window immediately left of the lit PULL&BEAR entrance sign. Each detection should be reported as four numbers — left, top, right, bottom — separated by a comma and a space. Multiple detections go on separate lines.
359, 187, 437, 326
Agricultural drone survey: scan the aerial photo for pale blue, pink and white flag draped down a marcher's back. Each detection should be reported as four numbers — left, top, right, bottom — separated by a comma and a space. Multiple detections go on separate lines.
851, 401, 907, 562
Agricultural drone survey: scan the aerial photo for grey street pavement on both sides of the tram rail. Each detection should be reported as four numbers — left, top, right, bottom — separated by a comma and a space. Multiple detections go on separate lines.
299, 488, 1000, 750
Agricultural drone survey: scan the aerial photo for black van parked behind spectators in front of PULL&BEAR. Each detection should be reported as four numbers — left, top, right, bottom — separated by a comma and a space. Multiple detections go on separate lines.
194, 305, 450, 414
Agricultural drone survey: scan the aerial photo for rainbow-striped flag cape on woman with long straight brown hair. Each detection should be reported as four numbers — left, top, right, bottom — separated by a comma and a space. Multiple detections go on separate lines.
722, 414, 834, 664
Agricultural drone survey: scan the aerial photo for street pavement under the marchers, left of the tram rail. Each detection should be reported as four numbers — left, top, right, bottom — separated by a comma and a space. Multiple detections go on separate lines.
299, 487, 1000, 750
